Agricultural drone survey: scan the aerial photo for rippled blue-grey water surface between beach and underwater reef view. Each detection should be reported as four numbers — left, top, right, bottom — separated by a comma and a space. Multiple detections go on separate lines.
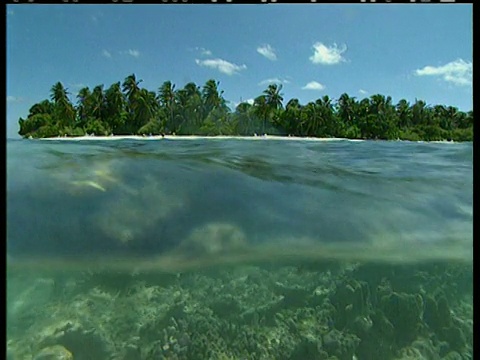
7, 139, 473, 268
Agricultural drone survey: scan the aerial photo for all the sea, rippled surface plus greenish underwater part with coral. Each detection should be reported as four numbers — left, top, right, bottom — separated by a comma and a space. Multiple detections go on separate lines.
6, 137, 473, 360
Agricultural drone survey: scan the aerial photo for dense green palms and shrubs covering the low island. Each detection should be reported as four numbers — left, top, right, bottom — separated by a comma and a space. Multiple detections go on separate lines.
19, 74, 473, 141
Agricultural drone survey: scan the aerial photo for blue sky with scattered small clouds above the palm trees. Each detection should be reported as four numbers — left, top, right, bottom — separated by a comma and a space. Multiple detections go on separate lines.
6, 4, 473, 137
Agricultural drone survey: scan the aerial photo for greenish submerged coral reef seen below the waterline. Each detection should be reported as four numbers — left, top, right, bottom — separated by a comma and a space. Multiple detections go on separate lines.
7, 260, 473, 360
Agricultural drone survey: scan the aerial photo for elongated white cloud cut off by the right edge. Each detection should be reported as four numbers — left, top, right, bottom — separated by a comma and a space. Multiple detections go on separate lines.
415, 59, 473, 86
